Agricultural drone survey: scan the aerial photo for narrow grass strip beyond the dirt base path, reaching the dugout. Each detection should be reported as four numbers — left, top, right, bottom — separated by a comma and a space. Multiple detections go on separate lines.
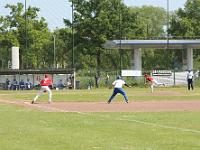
0, 87, 200, 102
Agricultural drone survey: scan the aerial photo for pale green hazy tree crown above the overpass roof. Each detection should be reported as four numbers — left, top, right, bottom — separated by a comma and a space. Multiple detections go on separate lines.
131, 5, 166, 39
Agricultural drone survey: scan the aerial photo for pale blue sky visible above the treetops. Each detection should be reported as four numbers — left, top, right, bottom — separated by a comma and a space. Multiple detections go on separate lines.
0, 0, 186, 30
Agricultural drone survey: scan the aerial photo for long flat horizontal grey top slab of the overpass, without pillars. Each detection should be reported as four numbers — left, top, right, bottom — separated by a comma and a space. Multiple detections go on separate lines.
103, 39, 200, 49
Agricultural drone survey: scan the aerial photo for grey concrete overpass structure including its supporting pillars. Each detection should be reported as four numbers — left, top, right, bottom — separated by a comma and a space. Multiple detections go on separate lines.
103, 39, 200, 70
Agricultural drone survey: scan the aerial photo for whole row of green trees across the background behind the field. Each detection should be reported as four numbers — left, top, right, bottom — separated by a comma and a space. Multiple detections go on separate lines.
0, 0, 200, 74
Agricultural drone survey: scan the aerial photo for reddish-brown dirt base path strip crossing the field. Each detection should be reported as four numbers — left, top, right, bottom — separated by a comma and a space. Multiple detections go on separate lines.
0, 100, 200, 113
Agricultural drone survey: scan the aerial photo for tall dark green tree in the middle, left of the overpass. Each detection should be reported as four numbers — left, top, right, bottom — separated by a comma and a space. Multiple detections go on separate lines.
65, 0, 137, 74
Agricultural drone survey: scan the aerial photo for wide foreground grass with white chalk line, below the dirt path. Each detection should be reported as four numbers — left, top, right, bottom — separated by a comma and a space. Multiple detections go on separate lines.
0, 104, 200, 150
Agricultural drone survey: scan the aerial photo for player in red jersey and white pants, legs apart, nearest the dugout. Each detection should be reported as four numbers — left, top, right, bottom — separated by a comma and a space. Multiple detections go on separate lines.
31, 74, 52, 104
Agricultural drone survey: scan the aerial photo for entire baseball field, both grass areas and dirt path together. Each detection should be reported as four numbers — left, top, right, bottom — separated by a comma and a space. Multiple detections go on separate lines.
0, 87, 200, 150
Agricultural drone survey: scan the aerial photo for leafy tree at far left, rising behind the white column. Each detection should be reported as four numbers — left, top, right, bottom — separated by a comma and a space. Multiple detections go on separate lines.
1, 3, 50, 68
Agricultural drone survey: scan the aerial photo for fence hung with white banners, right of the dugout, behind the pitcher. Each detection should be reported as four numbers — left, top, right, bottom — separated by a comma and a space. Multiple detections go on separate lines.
76, 70, 199, 89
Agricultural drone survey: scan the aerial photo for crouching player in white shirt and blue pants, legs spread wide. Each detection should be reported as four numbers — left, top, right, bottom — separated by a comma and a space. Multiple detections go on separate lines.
107, 76, 131, 104
